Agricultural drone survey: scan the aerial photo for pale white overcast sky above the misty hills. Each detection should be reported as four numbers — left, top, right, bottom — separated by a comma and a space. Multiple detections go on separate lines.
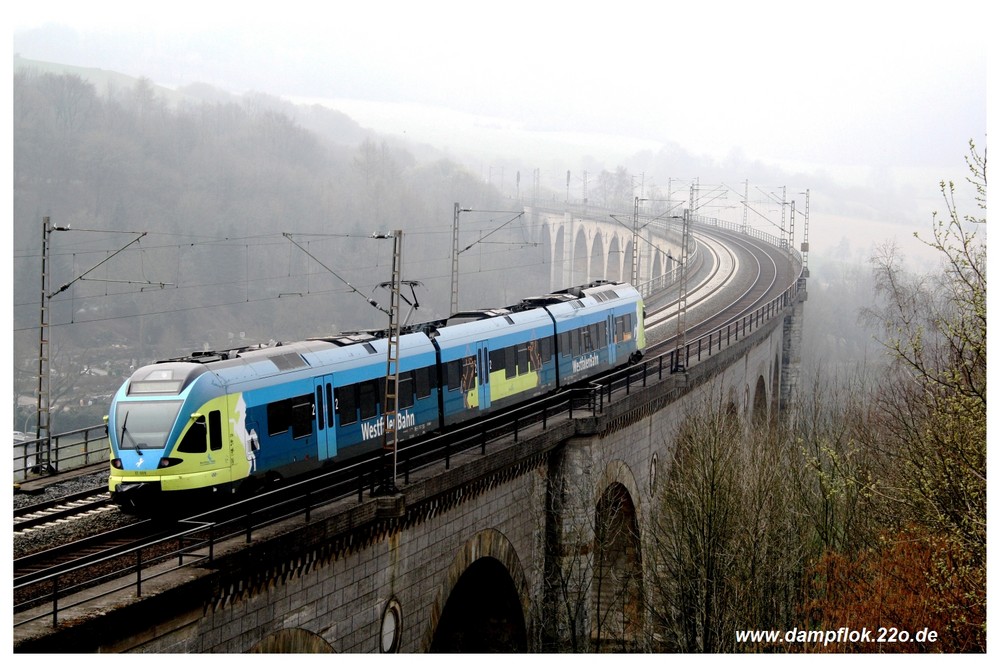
9, 0, 991, 260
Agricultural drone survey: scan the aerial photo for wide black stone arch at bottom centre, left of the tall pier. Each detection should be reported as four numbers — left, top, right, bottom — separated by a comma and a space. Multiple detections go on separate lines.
423, 528, 531, 653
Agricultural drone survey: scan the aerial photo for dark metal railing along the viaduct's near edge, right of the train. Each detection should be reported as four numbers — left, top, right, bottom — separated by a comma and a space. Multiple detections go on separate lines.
14, 264, 799, 628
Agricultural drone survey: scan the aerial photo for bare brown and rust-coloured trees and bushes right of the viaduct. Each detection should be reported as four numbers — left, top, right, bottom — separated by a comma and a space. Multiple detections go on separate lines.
647, 138, 986, 652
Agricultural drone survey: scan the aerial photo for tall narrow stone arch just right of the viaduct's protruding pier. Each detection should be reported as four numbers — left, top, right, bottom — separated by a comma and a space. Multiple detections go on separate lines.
590, 461, 644, 651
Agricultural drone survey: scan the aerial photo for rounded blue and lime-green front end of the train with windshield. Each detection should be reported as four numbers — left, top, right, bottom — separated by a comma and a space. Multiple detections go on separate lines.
108, 362, 246, 513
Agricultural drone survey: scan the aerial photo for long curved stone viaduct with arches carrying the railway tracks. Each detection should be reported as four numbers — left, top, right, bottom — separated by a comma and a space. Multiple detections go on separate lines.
14, 207, 805, 653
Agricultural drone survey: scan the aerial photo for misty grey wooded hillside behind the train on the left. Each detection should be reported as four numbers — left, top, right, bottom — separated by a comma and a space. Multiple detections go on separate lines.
13, 68, 548, 431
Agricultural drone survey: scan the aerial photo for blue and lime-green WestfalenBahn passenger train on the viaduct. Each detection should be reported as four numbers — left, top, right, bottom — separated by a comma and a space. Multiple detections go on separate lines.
107, 280, 646, 513
